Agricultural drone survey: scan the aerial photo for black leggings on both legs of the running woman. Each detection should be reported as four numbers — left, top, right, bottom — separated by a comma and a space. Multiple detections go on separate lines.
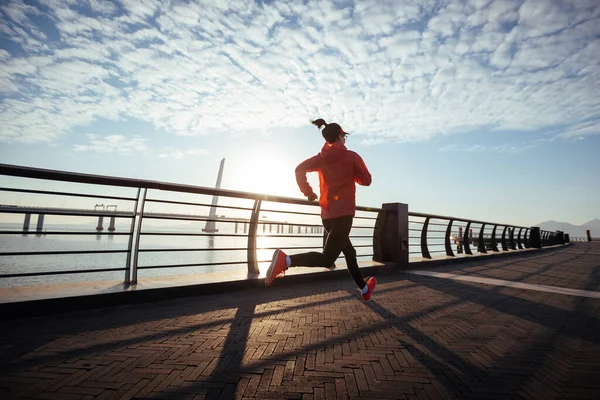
290, 215, 365, 289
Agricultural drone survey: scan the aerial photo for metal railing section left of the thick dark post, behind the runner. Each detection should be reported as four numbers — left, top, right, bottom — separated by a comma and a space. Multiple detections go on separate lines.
0, 164, 381, 284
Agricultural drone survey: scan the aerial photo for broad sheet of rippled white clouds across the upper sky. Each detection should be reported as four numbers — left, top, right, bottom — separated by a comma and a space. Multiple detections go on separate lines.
0, 0, 600, 144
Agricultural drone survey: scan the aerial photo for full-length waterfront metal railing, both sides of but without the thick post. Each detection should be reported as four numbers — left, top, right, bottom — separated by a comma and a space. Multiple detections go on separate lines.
0, 164, 564, 284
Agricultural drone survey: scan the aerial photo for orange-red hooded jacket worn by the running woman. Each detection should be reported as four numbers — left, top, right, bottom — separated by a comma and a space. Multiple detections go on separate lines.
296, 142, 371, 219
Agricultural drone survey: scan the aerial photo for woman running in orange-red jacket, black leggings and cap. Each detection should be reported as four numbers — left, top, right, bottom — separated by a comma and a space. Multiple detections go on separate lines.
265, 118, 377, 301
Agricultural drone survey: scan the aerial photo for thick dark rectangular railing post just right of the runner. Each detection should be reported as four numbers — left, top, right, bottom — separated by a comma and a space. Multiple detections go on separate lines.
373, 203, 408, 267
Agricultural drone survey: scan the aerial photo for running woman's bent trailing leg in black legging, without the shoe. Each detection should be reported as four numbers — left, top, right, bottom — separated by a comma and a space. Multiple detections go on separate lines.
290, 216, 352, 268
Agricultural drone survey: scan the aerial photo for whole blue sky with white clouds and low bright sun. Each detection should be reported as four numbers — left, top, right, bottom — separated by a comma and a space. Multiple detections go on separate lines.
0, 0, 600, 226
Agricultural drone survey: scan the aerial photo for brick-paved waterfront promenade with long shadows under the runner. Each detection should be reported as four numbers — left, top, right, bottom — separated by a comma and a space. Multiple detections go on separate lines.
0, 242, 600, 399
